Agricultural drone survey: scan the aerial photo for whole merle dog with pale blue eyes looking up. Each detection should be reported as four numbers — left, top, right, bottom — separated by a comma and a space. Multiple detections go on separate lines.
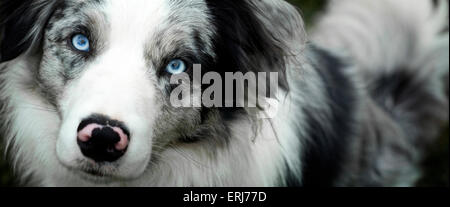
0, 0, 449, 187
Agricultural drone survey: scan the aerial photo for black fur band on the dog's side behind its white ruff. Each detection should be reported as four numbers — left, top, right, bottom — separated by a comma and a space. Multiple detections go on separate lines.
288, 46, 356, 187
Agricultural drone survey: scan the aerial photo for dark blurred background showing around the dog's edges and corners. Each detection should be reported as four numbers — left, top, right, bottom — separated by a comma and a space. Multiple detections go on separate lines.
0, 0, 450, 187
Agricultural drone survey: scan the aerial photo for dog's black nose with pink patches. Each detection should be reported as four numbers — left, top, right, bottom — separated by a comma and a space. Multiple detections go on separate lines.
77, 115, 130, 162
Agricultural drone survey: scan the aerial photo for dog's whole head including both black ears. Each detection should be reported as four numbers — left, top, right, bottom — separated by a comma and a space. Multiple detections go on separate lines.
0, 0, 300, 184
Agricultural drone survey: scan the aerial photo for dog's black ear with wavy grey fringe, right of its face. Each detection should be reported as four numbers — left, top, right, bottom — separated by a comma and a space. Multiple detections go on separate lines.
206, 0, 303, 89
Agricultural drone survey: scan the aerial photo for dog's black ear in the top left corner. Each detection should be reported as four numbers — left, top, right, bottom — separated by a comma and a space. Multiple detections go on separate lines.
0, 0, 63, 62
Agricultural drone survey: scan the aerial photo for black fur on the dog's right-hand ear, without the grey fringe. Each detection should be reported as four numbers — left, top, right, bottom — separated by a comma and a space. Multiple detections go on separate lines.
206, 0, 288, 103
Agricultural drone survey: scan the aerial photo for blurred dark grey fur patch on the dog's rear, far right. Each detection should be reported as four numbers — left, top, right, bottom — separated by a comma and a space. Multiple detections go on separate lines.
369, 67, 448, 148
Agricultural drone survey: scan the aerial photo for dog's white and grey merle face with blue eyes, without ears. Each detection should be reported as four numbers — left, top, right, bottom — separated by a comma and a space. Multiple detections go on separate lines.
38, 0, 214, 179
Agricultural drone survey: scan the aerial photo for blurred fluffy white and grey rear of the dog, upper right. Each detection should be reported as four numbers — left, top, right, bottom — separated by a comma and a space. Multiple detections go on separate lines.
311, 0, 449, 186
